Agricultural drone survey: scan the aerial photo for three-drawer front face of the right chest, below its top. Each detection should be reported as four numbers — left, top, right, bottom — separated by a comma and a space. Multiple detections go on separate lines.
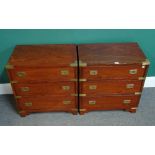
80, 64, 146, 113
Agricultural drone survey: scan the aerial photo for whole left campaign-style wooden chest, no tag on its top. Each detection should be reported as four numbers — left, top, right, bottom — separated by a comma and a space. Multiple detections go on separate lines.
6, 45, 78, 116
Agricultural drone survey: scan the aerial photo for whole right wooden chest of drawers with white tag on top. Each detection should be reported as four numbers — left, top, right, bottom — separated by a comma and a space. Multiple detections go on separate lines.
78, 43, 149, 114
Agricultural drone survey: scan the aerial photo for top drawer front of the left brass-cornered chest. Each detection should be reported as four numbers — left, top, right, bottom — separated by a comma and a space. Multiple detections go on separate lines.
9, 67, 76, 82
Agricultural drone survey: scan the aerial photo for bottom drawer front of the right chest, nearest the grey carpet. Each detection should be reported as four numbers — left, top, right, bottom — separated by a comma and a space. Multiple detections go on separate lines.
80, 95, 139, 110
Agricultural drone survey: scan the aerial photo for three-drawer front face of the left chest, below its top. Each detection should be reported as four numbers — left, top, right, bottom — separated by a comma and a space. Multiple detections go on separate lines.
9, 67, 77, 113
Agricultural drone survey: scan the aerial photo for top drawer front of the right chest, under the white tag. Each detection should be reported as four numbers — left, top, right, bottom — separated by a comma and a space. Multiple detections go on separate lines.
80, 65, 145, 80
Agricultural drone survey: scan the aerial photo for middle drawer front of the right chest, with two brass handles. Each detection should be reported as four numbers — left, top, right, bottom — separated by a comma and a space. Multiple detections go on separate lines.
80, 80, 142, 95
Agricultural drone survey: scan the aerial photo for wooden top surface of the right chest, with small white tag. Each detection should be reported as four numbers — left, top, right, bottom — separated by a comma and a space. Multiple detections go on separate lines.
78, 43, 146, 65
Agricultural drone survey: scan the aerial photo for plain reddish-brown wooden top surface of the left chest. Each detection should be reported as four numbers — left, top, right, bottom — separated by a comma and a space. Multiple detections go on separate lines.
8, 44, 77, 67
